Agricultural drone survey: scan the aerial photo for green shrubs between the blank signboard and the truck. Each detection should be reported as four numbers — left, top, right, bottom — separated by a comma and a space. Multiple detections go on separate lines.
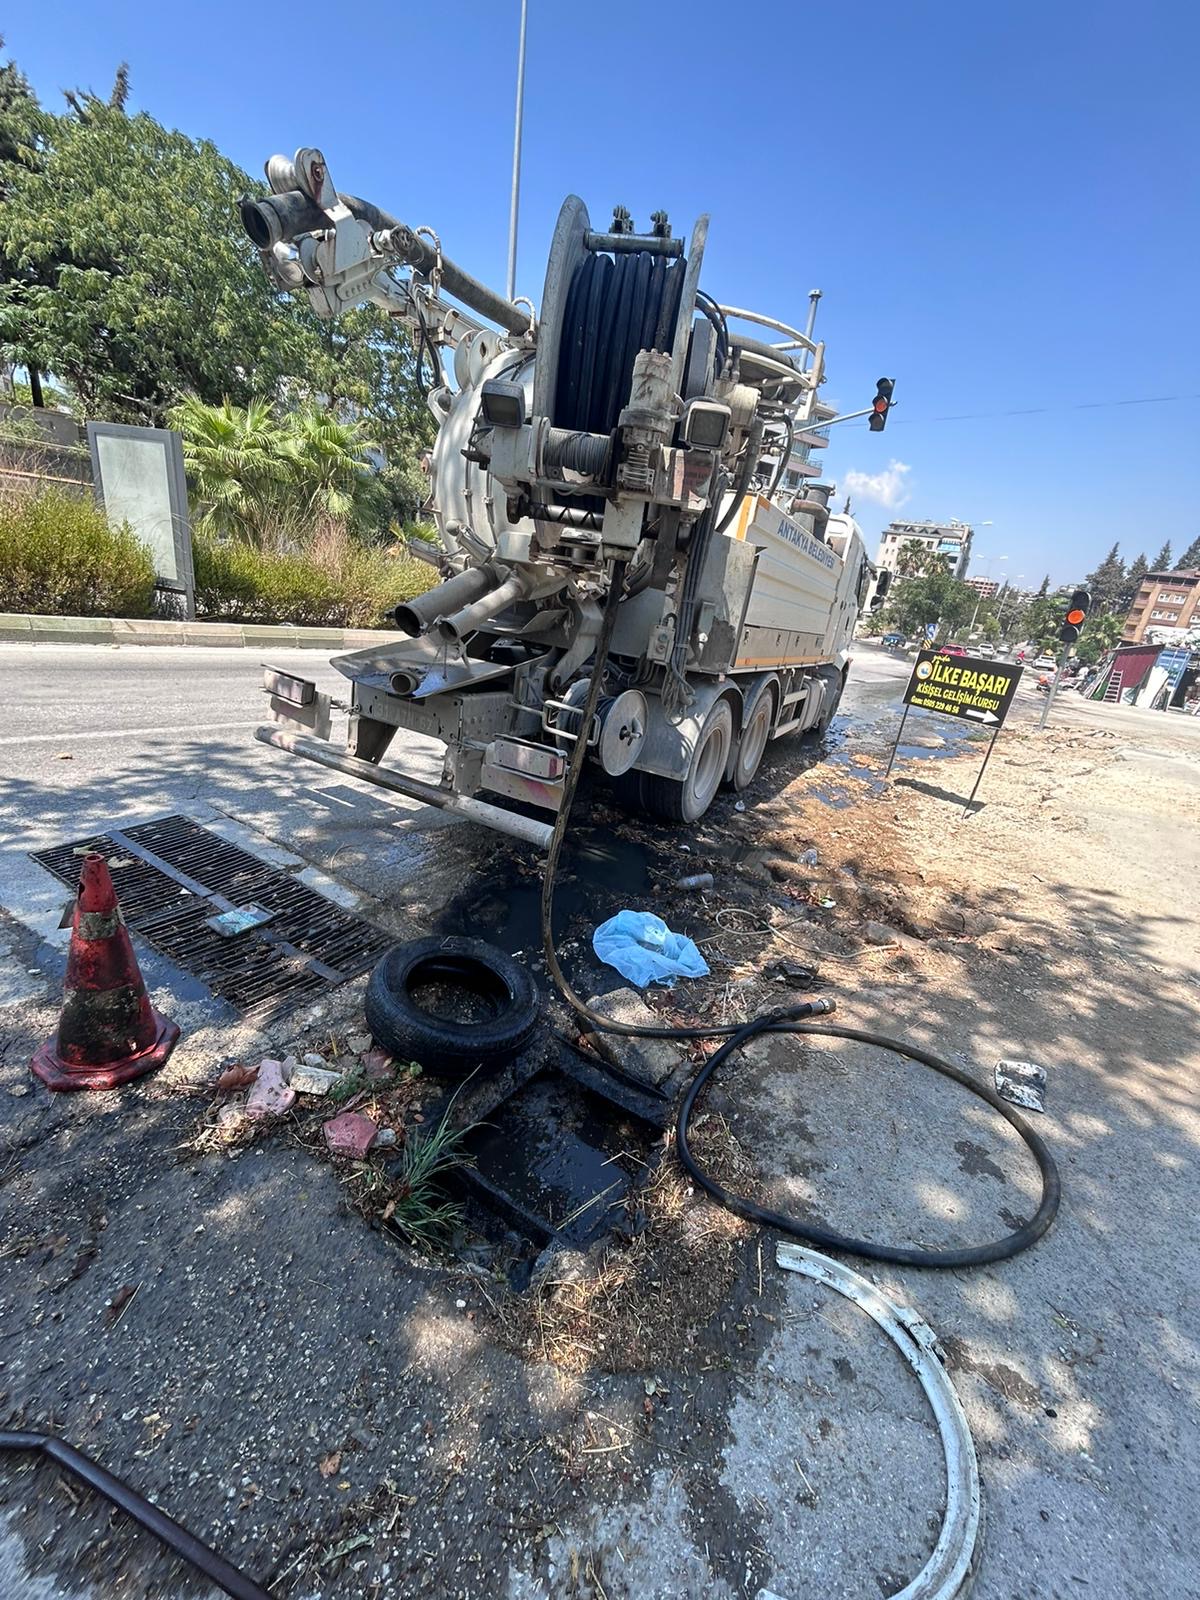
194, 531, 435, 627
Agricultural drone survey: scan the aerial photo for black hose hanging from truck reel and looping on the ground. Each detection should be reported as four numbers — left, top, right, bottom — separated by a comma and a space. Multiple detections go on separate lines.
541, 562, 1061, 1267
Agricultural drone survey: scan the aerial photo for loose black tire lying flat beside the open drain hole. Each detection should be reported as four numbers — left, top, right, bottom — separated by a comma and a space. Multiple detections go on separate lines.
365, 938, 541, 1077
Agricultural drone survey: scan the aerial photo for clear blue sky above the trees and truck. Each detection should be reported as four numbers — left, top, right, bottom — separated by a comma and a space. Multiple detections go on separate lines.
5, 0, 1200, 584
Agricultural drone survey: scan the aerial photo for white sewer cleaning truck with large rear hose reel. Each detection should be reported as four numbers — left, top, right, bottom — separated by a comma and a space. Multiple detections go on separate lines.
242, 149, 893, 845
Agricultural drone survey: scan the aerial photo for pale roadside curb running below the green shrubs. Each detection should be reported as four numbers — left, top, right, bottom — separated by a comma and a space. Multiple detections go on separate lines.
0, 611, 405, 650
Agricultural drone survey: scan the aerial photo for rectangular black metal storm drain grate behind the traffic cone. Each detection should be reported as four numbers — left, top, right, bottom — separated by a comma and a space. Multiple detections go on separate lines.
34, 816, 392, 1011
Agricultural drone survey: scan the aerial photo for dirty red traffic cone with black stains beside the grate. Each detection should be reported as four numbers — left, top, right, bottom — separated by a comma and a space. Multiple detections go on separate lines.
32, 854, 179, 1090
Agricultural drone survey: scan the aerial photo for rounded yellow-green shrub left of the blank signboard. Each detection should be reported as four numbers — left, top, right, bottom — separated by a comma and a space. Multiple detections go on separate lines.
0, 490, 154, 616
